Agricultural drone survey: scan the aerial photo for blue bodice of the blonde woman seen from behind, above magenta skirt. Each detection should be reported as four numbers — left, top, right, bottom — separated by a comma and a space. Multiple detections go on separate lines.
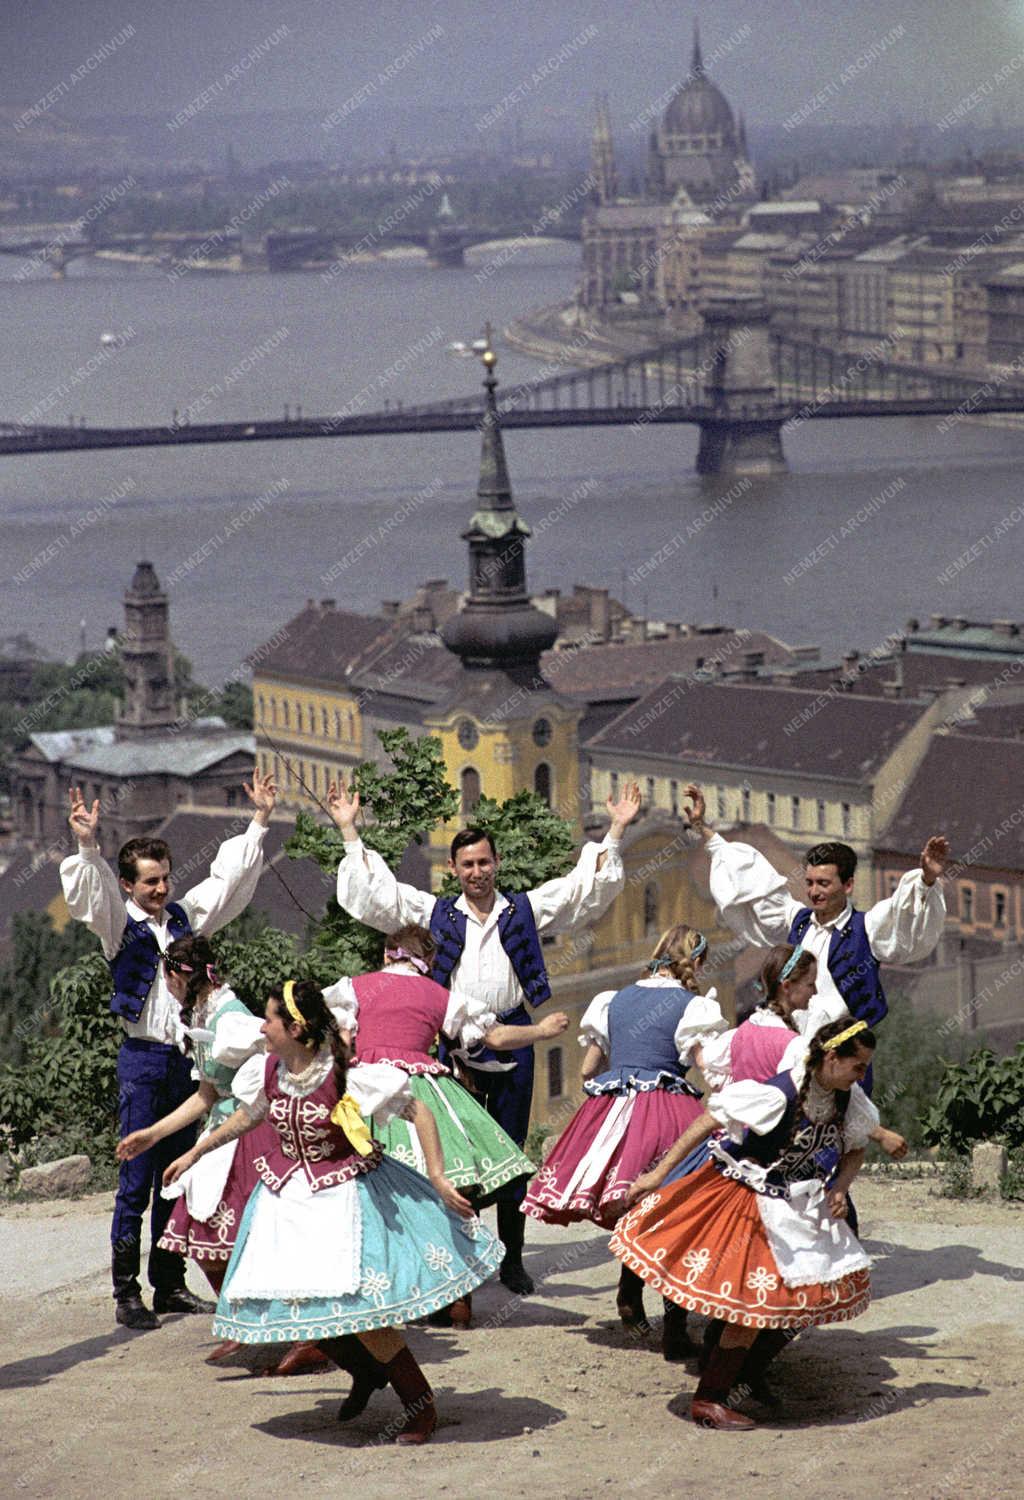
583, 984, 700, 1098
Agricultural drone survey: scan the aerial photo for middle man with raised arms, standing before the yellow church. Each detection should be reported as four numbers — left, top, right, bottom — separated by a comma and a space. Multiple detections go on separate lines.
327, 783, 640, 1296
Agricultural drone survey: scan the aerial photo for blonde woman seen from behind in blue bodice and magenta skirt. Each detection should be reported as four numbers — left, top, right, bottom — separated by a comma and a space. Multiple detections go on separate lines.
523, 923, 726, 1361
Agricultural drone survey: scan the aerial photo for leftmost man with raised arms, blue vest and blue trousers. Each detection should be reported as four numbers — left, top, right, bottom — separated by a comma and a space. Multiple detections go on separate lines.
60, 770, 277, 1331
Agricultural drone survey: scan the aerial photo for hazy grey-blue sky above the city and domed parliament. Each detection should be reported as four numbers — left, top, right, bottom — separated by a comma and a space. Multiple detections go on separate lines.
0, 0, 1024, 129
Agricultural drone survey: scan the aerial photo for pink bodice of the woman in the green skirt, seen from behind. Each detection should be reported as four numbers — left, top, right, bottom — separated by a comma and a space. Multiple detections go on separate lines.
352, 972, 451, 1073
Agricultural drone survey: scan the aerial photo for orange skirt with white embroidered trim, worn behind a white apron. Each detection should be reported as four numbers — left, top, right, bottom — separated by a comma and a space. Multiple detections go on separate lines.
610, 1163, 871, 1329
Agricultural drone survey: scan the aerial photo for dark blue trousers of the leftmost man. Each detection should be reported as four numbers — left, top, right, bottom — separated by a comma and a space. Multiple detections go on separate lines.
111, 1037, 196, 1298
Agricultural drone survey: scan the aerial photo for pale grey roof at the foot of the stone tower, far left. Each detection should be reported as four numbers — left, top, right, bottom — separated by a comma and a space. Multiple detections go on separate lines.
30, 717, 256, 777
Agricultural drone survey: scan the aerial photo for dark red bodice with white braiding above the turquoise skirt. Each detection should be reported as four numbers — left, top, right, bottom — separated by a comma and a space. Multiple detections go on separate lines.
253, 1058, 381, 1193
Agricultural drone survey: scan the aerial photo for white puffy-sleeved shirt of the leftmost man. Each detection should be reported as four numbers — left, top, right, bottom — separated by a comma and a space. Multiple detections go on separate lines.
60, 822, 267, 1046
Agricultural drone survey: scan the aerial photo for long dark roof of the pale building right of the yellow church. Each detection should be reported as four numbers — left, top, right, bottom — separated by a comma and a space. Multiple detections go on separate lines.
586, 678, 927, 782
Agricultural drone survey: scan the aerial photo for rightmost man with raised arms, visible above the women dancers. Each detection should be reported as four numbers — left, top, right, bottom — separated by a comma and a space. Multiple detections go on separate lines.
687, 786, 949, 1026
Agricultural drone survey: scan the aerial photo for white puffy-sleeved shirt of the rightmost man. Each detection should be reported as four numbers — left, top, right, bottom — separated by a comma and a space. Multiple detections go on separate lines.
706, 834, 946, 1025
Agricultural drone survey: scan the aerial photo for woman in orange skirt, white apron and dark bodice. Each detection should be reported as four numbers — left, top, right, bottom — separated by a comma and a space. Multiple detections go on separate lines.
610, 1019, 877, 1430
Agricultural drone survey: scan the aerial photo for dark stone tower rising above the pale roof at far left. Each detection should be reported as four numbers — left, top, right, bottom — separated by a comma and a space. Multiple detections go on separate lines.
115, 563, 177, 740
